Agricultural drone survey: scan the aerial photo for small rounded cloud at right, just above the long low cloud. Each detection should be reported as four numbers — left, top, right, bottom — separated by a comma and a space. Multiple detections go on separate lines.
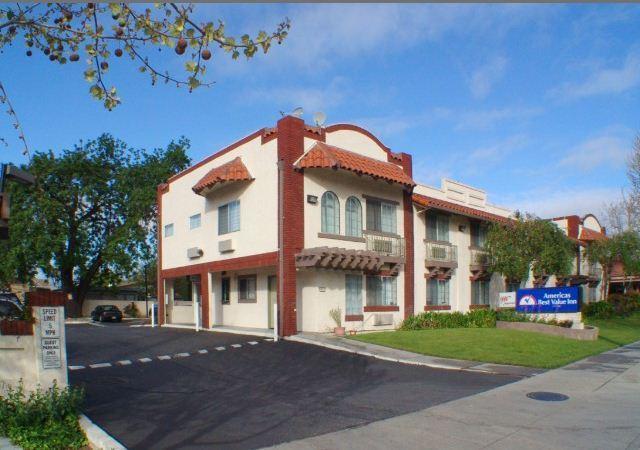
559, 135, 630, 172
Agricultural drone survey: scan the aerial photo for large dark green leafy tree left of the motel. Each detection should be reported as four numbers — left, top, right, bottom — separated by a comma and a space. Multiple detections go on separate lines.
0, 134, 189, 314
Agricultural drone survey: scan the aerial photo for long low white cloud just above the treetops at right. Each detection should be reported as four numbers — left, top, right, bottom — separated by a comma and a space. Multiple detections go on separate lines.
499, 188, 620, 218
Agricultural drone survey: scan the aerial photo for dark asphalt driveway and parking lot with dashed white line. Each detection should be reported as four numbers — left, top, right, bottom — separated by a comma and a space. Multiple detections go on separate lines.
67, 324, 518, 449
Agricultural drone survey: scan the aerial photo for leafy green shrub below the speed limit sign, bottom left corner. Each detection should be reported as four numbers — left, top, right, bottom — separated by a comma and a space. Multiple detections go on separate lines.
0, 383, 87, 450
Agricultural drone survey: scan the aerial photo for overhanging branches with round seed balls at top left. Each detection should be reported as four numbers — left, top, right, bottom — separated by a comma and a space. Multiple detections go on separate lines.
0, 3, 290, 110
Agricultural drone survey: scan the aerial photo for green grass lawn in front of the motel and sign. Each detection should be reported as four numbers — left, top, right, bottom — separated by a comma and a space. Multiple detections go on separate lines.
351, 313, 640, 368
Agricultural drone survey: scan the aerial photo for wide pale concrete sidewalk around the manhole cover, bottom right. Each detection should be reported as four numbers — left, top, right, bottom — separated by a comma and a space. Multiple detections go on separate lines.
274, 341, 640, 450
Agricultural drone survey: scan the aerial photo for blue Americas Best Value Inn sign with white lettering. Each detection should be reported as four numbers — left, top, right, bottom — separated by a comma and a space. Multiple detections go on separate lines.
516, 286, 580, 314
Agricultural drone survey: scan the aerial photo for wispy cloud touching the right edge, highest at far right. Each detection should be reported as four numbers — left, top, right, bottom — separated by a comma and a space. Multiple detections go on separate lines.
549, 52, 640, 99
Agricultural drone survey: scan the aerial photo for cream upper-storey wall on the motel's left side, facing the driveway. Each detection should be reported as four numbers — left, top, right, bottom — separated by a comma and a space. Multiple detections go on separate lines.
162, 136, 278, 269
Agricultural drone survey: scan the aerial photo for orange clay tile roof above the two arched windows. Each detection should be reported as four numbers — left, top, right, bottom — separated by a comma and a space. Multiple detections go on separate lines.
296, 142, 416, 186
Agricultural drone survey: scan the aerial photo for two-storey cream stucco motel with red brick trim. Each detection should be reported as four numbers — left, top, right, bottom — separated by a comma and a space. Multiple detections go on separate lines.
158, 116, 604, 336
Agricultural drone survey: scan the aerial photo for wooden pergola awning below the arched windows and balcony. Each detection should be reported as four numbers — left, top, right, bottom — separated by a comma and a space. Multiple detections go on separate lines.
296, 247, 404, 276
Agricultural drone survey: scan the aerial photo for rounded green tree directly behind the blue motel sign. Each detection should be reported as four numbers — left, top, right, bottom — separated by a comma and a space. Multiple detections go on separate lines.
485, 213, 575, 281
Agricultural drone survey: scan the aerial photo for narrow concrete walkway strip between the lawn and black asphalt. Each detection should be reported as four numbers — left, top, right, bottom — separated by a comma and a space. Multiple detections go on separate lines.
287, 333, 544, 377
